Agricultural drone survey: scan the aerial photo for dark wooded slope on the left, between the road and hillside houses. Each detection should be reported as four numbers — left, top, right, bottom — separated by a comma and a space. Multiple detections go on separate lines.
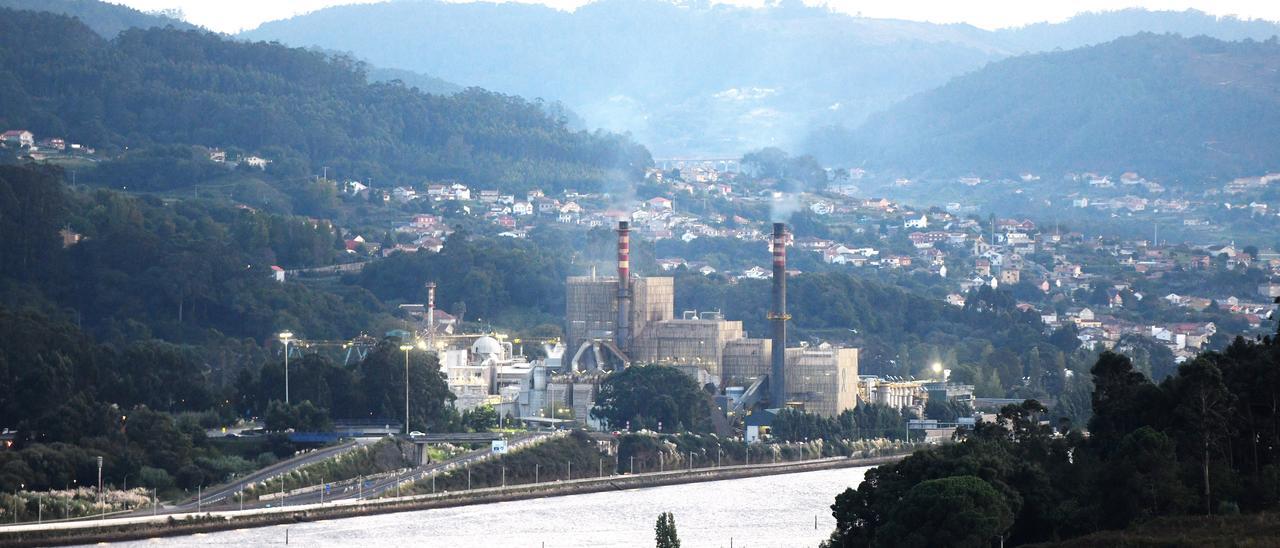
0, 166, 458, 489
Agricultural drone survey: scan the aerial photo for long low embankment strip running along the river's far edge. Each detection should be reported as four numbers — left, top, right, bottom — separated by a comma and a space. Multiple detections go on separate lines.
0, 455, 904, 547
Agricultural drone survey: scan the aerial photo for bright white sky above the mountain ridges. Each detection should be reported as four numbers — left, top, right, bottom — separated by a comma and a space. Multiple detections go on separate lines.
115, 0, 1280, 32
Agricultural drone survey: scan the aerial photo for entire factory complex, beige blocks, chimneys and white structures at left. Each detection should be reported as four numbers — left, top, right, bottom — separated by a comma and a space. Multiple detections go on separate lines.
428, 222, 863, 426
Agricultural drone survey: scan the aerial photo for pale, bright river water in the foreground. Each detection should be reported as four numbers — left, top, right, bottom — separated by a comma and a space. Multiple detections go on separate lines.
127, 467, 868, 548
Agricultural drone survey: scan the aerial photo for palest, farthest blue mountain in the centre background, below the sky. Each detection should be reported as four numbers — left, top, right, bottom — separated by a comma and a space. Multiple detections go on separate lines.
242, 0, 1280, 155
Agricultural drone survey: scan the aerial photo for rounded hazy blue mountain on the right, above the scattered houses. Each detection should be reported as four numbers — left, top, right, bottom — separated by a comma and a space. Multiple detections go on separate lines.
818, 33, 1280, 182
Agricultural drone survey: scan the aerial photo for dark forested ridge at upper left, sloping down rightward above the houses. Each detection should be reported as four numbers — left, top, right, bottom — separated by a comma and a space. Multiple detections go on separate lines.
0, 10, 650, 191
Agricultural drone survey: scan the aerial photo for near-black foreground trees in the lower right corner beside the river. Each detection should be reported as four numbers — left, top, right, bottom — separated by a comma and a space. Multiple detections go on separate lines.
828, 337, 1280, 547
